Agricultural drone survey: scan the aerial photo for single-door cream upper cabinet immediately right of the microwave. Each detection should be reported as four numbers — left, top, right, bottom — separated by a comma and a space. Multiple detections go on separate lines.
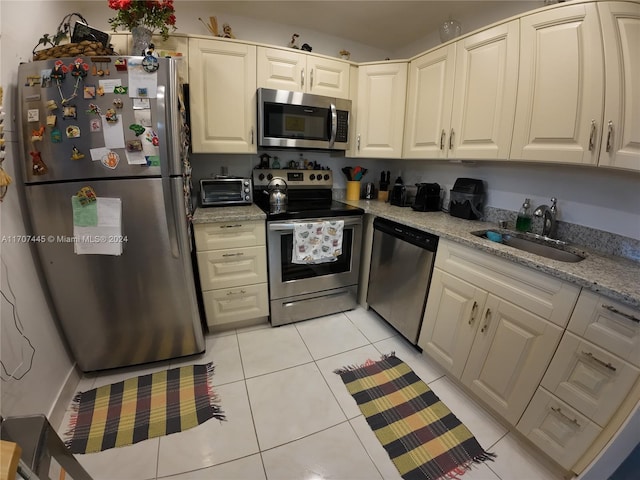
347, 62, 407, 158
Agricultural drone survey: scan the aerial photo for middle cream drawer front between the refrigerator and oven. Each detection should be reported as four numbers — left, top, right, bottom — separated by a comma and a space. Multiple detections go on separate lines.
197, 247, 267, 291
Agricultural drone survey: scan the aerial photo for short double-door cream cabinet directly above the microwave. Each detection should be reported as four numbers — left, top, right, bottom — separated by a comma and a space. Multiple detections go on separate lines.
257, 47, 349, 99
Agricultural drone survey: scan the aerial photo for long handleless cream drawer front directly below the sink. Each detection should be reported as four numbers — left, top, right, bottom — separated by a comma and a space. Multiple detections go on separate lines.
435, 239, 580, 327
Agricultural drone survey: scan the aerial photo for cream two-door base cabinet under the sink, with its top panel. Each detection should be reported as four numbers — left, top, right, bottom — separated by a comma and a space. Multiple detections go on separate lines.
418, 239, 580, 425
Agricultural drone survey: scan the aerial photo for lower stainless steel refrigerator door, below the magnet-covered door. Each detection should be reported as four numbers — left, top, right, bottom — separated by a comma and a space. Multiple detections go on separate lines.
25, 177, 204, 371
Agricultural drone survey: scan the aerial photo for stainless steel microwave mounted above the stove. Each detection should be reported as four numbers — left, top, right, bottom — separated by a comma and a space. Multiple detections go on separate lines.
257, 88, 351, 150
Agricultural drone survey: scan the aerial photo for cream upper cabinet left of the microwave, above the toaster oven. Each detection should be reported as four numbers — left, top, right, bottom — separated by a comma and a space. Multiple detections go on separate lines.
189, 38, 257, 153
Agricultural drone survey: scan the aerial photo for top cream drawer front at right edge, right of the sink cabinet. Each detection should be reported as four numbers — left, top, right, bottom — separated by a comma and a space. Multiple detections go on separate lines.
567, 290, 640, 367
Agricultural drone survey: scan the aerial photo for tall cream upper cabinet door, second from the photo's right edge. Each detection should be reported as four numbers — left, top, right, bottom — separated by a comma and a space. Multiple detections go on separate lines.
511, 3, 604, 165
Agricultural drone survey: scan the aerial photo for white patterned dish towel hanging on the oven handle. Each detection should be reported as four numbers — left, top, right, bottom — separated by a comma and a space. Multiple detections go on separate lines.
291, 220, 344, 264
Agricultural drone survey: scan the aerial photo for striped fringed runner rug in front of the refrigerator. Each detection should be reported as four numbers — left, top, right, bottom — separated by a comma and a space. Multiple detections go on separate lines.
65, 363, 225, 453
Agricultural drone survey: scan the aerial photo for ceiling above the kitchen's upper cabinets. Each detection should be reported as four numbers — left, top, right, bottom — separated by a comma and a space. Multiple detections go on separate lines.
208, 0, 544, 50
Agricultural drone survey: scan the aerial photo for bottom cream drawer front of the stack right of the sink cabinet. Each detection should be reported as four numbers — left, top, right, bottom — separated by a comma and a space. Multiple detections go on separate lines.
517, 388, 602, 470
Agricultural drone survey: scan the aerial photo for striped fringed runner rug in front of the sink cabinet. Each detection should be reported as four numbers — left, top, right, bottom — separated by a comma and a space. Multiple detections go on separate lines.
335, 353, 495, 480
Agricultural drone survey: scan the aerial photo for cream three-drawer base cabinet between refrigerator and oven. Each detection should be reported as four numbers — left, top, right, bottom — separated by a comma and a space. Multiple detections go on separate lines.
194, 221, 269, 329
